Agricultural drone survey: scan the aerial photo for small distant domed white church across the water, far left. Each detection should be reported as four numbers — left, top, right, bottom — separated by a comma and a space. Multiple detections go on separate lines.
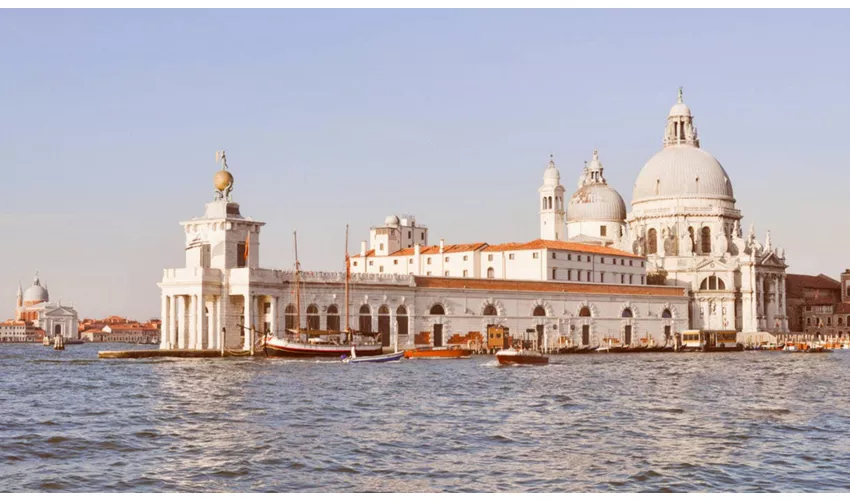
0, 273, 80, 342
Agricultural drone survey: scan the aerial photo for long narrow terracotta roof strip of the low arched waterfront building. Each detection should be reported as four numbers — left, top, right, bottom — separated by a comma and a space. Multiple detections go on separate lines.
414, 276, 686, 297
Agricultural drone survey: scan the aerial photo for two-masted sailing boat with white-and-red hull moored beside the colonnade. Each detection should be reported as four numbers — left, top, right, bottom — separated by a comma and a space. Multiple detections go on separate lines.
264, 226, 383, 359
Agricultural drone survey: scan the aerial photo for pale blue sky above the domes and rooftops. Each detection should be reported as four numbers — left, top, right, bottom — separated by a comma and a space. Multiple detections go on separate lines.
0, 9, 850, 319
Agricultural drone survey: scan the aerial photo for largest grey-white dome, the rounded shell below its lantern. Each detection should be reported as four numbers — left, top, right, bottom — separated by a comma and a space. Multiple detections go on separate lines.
632, 145, 735, 205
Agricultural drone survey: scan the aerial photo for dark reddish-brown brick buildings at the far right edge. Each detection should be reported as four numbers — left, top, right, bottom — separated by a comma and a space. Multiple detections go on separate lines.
786, 269, 850, 338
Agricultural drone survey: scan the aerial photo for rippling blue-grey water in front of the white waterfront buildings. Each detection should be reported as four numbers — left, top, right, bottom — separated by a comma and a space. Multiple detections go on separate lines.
0, 345, 850, 492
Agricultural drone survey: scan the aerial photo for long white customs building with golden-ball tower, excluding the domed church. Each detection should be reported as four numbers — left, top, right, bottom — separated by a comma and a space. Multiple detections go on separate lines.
159, 156, 688, 350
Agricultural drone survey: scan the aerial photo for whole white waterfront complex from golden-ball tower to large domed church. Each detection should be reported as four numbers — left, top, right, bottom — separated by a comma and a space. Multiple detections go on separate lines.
159, 90, 788, 356
